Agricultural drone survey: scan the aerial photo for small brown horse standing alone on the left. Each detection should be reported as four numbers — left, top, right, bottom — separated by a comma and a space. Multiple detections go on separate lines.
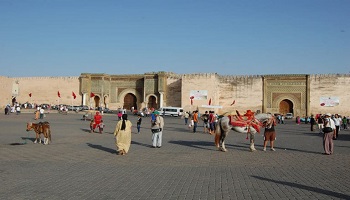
26, 121, 51, 144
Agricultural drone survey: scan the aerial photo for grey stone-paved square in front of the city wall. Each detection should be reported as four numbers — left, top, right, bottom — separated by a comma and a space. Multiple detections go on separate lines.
0, 113, 350, 200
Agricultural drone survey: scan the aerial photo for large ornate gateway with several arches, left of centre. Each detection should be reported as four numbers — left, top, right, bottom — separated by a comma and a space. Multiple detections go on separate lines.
79, 72, 166, 110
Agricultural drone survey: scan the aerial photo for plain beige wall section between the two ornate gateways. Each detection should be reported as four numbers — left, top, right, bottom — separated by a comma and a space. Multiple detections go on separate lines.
182, 73, 262, 114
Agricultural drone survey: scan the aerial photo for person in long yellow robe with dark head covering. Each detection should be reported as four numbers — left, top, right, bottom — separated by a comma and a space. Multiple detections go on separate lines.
114, 114, 132, 155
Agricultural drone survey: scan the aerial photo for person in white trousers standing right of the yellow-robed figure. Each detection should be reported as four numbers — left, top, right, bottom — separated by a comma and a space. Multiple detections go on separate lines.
151, 110, 164, 148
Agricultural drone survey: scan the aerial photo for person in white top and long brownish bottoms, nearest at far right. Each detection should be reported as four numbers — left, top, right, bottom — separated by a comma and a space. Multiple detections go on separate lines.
323, 113, 335, 155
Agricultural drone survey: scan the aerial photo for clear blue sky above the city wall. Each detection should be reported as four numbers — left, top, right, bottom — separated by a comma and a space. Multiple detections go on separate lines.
0, 0, 350, 77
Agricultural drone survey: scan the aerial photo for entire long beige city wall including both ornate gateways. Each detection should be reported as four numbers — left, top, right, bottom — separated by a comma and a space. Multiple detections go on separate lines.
0, 72, 350, 116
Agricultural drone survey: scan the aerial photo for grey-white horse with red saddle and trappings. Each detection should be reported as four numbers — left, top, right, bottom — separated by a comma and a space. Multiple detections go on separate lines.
215, 110, 274, 152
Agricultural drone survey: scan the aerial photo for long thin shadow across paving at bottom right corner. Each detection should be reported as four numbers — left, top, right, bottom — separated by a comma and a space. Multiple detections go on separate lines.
252, 176, 350, 199
